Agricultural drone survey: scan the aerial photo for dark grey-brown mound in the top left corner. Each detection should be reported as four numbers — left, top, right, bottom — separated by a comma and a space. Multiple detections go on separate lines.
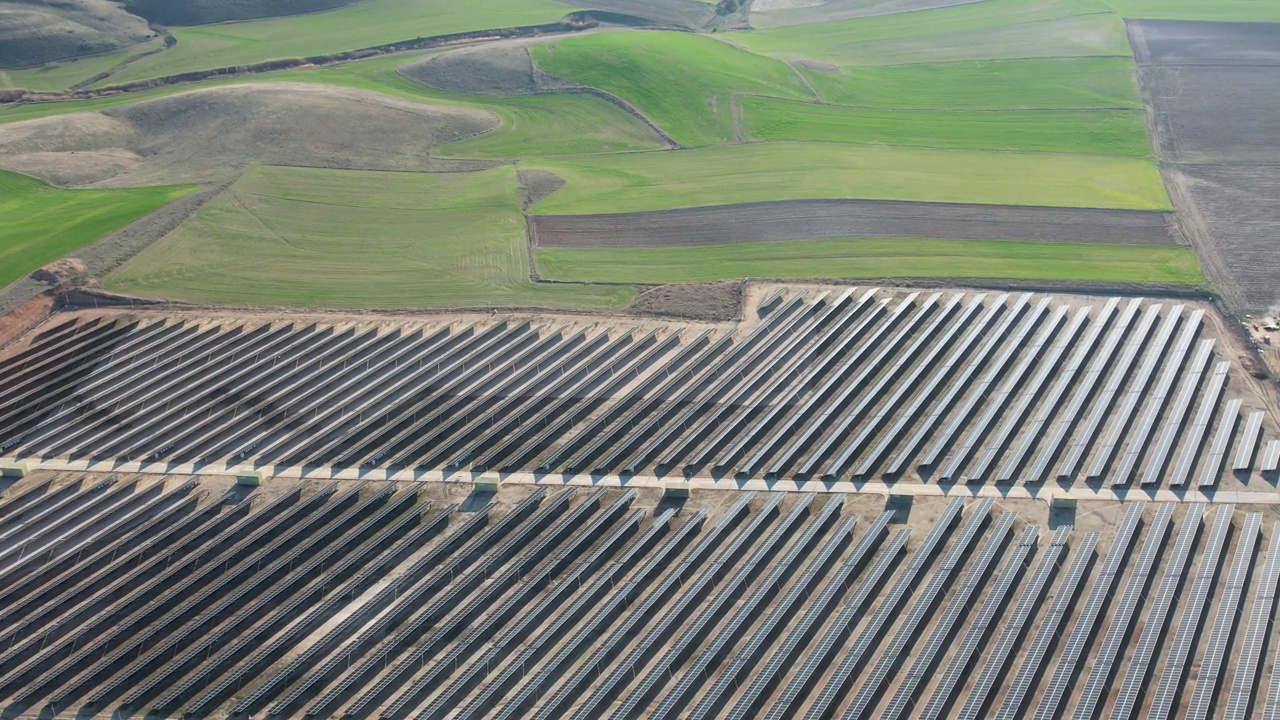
0, 0, 155, 69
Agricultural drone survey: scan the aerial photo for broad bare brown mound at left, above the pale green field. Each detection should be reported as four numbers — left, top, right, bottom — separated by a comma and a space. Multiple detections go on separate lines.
0, 83, 499, 187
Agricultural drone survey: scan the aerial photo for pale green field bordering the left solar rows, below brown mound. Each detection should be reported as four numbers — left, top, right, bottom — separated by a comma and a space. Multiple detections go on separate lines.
106, 167, 632, 309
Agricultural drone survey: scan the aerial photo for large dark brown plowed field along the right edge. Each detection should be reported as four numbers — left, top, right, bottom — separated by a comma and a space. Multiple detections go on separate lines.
1128, 20, 1280, 314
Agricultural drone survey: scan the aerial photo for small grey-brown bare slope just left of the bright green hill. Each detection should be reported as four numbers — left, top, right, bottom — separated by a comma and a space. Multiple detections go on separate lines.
399, 44, 539, 95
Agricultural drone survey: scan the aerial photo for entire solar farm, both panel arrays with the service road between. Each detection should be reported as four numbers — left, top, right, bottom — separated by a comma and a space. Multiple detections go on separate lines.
0, 286, 1280, 719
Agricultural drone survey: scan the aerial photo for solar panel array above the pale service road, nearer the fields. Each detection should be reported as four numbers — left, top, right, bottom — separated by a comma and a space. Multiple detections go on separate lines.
0, 288, 1280, 488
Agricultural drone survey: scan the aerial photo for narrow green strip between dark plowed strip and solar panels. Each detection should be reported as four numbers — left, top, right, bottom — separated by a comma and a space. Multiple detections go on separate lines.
538, 238, 1204, 286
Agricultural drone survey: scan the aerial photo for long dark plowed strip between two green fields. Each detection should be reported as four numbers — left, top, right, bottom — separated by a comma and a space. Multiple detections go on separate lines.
530, 200, 1178, 247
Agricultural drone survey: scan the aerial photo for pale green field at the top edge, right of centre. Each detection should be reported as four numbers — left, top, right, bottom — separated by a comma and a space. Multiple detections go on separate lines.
730, 0, 1130, 65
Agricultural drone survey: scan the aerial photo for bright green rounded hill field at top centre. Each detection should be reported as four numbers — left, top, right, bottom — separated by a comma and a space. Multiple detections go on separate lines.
532, 32, 813, 146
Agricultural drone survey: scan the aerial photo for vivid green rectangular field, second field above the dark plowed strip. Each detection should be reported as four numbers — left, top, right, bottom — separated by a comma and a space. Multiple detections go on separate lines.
741, 97, 1151, 156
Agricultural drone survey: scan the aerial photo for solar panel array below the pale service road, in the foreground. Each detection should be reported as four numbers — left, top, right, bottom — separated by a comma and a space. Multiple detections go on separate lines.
0, 473, 1280, 719
